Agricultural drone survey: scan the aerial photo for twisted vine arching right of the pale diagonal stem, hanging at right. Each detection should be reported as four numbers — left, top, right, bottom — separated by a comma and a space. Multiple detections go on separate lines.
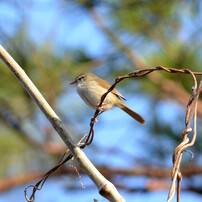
81, 66, 202, 201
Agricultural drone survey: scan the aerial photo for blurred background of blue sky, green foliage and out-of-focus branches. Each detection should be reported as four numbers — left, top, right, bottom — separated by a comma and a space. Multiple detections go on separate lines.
0, 0, 202, 202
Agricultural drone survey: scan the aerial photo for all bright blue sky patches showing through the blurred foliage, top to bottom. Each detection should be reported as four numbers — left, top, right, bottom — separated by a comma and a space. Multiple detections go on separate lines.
0, 0, 201, 202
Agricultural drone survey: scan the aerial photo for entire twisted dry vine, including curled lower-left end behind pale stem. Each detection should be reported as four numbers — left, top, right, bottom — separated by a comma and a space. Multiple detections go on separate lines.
25, 66, 202, 201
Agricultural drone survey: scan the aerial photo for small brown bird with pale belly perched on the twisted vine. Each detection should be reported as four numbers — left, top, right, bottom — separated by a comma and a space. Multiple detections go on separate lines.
71, 73, 145, 124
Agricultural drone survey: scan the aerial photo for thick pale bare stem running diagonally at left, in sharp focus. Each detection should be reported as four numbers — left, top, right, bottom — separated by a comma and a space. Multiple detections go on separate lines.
0, 45, 125, 202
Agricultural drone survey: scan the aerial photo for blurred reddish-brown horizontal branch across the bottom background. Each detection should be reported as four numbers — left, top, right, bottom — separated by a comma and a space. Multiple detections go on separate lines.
0, 165, 202, 192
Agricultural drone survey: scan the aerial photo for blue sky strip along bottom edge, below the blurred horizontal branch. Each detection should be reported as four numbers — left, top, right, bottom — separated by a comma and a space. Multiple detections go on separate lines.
0, 176, 201, 202
